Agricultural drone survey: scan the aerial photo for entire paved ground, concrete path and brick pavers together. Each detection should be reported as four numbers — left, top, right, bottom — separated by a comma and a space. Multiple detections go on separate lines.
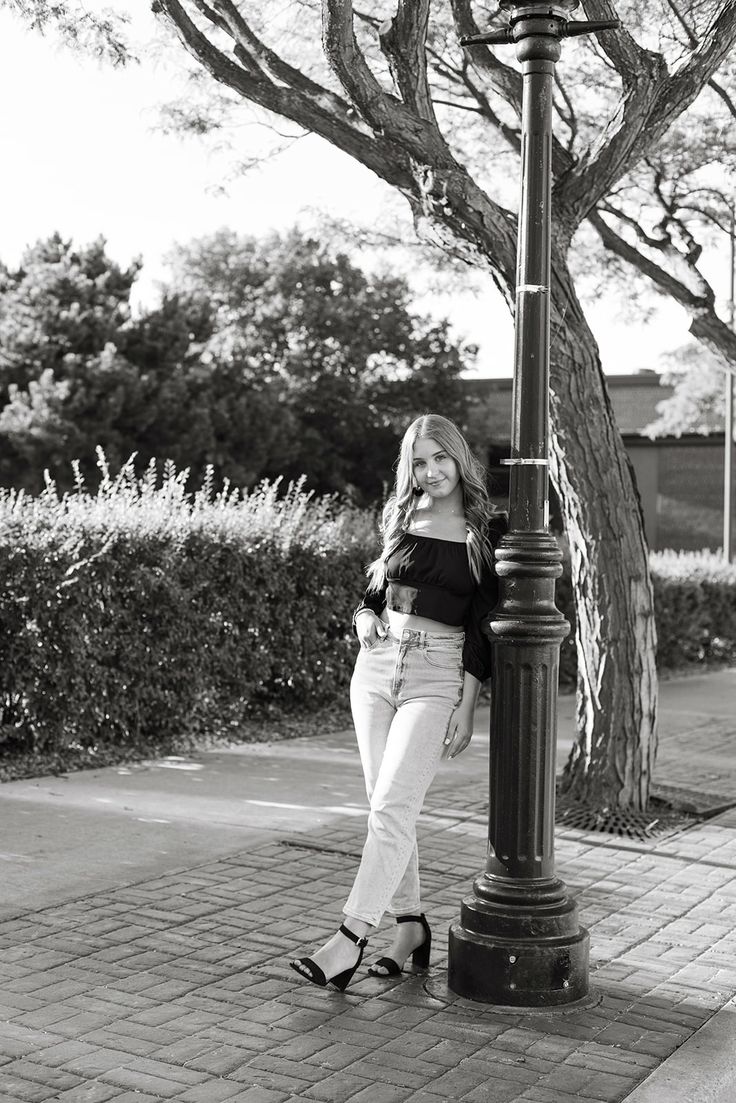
0, 671, 736, 1103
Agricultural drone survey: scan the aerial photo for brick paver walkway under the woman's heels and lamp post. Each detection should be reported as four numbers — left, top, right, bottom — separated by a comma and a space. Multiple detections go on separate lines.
0, 692, 736, 1103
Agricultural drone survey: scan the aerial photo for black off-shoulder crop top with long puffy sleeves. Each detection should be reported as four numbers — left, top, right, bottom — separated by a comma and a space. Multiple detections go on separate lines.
355, 513, 506, 682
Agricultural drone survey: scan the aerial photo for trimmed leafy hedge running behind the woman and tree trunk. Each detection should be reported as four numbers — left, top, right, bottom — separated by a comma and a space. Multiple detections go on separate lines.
0, 458, 736, 752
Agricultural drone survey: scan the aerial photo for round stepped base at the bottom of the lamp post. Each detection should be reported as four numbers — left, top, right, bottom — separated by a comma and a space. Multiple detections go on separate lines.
447, 877, 589, 1007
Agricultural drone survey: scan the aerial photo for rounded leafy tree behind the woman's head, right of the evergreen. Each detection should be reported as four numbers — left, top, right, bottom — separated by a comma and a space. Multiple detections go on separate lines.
164, 231, 472, 502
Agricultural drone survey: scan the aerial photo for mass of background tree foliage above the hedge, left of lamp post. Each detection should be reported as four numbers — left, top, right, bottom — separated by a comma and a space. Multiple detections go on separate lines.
0, 231, 472, 502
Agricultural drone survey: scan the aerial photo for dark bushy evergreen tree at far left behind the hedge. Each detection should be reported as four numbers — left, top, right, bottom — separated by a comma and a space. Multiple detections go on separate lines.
0, 234, 225, 492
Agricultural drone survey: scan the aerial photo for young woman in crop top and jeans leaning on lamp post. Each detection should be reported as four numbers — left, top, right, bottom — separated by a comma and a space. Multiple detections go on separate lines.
290, 414, 505, 990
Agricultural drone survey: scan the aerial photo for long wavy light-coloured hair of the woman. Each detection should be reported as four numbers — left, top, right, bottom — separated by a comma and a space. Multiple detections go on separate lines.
365, 414, 498, 590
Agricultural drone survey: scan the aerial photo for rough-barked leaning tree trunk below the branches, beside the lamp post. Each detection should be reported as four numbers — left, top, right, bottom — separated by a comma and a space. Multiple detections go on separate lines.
551, 257, 657, 811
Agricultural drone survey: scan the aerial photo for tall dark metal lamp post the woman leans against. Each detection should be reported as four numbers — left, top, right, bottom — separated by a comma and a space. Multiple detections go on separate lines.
448, 0, 618, 1007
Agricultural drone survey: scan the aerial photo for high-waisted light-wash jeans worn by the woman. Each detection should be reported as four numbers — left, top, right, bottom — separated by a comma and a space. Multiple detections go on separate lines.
343, 629, 465, 927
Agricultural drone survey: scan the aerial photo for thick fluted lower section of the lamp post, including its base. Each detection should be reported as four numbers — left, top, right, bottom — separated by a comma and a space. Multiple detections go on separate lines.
448, 533, 588, 1007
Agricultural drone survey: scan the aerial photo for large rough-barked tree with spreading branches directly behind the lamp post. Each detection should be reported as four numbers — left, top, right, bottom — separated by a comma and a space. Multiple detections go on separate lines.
143, 0, 736, 806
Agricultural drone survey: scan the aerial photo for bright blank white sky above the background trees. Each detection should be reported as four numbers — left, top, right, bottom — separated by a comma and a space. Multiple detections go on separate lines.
0, 7, 706, 376
